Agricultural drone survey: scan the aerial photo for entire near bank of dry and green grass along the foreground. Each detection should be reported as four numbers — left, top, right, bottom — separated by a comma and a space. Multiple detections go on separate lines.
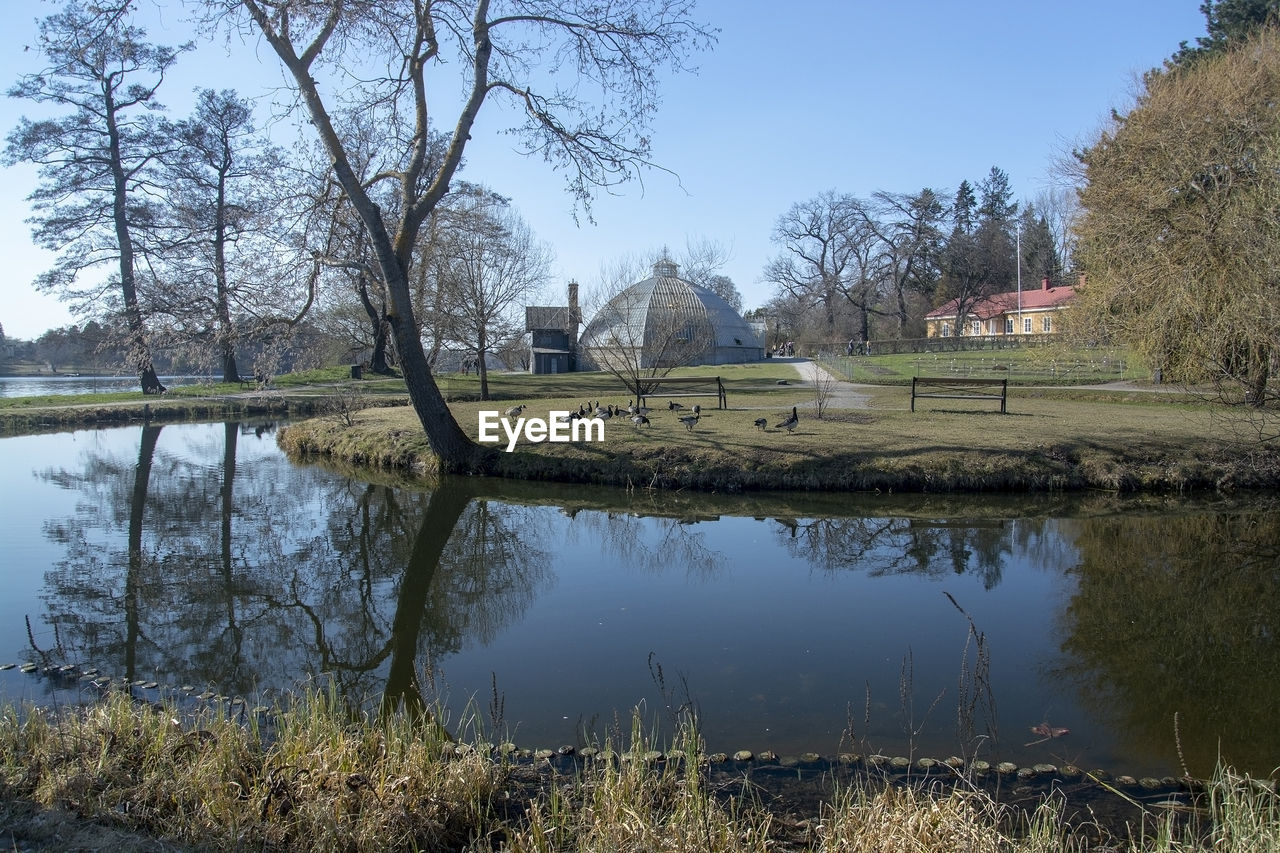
0, 693, 1280, 853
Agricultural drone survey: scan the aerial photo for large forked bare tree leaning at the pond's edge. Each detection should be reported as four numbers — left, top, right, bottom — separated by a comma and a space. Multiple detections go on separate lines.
205, 0, 712, 471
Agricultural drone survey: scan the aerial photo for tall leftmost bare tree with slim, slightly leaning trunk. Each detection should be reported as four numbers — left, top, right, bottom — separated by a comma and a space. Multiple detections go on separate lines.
5, 1, 190, 393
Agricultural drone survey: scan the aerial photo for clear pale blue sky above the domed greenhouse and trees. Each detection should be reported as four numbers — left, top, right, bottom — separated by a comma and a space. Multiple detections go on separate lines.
0, 0, 1204, 339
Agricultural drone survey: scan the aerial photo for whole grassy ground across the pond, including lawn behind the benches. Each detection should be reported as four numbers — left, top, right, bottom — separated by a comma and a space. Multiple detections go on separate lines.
0, 353, 1280, 492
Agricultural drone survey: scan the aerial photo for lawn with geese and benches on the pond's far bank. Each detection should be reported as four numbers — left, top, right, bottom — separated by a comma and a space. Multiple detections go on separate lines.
280, 365, 1280, 492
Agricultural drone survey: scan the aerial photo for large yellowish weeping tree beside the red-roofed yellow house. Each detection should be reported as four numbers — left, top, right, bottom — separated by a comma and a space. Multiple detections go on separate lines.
1071, 28, 1280, 410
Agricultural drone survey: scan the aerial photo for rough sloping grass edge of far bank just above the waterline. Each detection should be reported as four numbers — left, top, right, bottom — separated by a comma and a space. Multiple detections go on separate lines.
278, 409, 1280, 493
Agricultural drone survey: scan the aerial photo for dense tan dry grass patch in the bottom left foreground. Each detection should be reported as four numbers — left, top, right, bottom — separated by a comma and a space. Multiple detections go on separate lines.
0, 694, 504, 850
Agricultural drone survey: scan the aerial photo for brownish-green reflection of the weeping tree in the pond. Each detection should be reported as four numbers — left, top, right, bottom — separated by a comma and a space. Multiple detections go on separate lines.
1060, 500, 1280, 775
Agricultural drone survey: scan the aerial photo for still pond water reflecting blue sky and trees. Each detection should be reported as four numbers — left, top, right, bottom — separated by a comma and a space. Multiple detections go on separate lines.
0, 424, 1280, 775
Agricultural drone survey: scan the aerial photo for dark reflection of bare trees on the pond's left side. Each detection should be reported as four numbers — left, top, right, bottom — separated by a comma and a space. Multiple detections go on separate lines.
42, 424, 549, 708
